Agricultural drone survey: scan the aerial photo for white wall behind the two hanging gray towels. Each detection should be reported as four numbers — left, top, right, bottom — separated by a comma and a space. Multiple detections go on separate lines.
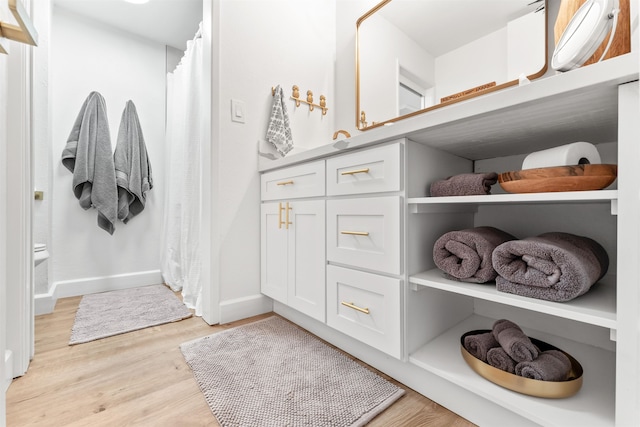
48, 7, 166, 296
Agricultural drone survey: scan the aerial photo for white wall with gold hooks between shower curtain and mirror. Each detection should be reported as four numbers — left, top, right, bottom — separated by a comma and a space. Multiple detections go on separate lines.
213, 0, 338, 321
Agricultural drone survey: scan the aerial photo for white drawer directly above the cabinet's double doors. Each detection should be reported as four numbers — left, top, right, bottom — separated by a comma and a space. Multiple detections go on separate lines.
260, 160, 325, 200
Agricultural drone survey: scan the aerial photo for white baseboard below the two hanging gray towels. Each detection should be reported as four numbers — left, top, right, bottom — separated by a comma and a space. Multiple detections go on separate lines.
34, 270, 163, 316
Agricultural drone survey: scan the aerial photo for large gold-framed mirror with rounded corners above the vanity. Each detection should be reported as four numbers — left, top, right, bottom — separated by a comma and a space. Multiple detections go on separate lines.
356, 0, 547, 130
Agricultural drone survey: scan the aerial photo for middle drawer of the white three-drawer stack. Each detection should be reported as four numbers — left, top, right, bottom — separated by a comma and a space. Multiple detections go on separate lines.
327, 196, 401, 274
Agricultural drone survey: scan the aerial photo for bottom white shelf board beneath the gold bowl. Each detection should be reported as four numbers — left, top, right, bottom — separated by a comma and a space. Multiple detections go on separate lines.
409, 315, 615, 427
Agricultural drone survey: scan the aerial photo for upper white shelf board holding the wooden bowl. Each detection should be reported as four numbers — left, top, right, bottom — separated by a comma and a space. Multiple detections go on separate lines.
408, 190, 618, 214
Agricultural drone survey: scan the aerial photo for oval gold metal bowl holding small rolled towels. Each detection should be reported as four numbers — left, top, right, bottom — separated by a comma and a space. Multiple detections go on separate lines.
460, 329, 583, 399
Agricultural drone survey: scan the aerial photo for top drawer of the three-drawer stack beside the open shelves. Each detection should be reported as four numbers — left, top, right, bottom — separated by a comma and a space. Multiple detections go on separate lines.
327, 143, 401, 196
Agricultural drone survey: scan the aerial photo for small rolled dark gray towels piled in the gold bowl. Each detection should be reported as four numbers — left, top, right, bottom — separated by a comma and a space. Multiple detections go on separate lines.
463, 319, 571, 381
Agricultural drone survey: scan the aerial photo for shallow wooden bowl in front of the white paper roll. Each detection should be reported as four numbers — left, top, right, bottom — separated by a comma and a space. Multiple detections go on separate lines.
498, 164, 618, 193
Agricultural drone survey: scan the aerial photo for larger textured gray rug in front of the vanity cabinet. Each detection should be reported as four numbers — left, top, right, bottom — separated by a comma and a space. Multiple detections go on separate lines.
180, 317, 404, 427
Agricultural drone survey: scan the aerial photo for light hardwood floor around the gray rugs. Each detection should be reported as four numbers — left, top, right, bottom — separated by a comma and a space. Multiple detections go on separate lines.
7, 297, 473, 427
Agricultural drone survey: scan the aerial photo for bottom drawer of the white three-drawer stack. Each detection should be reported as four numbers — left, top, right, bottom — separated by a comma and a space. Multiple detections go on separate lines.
327, 265, 402, 359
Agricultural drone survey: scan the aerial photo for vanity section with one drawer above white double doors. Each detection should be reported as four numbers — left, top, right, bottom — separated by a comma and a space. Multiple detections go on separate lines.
260, 161, 325, 322
